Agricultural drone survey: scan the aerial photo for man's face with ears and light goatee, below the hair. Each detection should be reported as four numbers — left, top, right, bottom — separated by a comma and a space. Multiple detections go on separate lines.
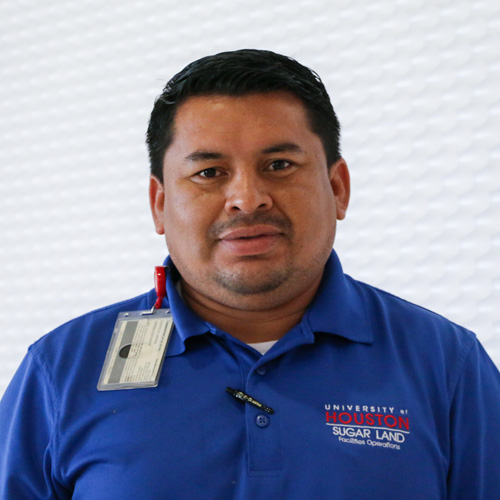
150, 92, 349, 309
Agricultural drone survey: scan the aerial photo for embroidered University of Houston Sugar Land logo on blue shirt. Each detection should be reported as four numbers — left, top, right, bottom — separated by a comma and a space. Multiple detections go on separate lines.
325, 404, 410, 450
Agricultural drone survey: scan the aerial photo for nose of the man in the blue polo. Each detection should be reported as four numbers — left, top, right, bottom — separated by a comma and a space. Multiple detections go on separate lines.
225, 172, 273, 215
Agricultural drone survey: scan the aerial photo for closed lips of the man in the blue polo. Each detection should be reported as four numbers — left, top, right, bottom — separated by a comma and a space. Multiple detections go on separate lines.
219, 224, 283, 256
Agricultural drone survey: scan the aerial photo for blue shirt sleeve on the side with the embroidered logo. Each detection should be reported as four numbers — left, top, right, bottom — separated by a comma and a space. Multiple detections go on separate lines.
448, 339, 500, 500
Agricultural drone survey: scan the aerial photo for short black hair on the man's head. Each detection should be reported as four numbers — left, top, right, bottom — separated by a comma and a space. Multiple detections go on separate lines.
146, 49, 340, 182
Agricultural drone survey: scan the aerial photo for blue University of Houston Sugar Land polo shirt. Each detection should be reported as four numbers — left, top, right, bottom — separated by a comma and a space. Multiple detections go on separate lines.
0, 253, 500, 500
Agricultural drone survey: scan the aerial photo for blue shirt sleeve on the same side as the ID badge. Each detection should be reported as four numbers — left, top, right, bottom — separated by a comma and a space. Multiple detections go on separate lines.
0, 351, 71, 500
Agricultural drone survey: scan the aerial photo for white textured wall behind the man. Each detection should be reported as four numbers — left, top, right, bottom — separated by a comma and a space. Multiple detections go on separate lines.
0, 0, 500, 394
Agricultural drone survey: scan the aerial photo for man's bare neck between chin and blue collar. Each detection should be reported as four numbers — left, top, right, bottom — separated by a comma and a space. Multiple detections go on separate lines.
181, 276, 321, 343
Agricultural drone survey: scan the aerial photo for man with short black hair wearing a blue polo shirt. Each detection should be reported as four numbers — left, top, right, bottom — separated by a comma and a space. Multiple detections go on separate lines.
0, 50, 500, 500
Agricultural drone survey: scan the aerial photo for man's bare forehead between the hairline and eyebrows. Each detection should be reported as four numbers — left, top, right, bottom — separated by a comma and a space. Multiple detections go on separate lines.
171, 91, 319, 152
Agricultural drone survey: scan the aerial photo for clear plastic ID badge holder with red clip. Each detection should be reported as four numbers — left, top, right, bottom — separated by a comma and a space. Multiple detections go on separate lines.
97, 266, 174, 391
